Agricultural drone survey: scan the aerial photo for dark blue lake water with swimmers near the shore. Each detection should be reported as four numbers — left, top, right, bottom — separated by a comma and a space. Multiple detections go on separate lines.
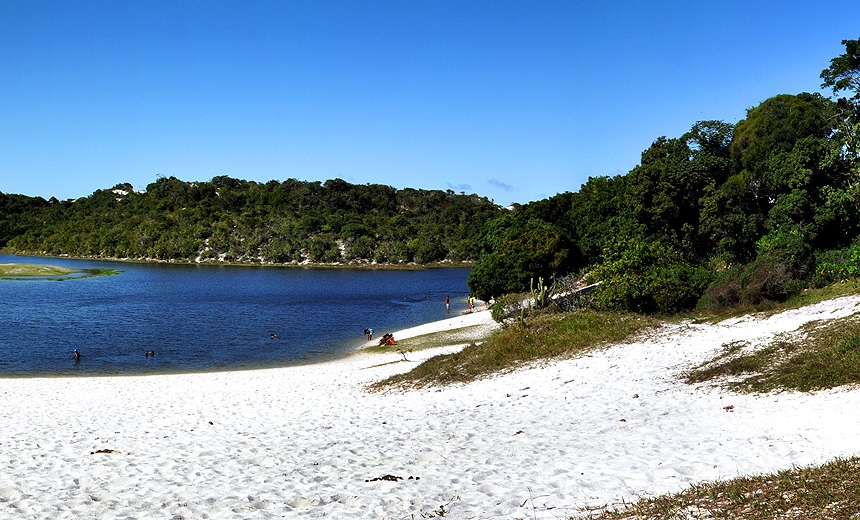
0, 255, 469, 376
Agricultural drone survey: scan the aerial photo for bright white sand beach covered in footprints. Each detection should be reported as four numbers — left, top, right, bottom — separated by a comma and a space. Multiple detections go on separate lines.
0, 297, 860, 519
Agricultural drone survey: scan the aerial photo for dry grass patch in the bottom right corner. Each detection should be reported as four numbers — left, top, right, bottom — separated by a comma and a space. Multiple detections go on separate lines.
590, 457, 860, 520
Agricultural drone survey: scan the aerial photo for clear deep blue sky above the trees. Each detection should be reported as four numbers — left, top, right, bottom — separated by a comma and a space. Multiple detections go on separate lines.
0, 0, 860, 204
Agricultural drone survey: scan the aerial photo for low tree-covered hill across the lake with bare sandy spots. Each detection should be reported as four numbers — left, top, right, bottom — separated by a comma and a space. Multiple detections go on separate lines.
0, 177, 502, 264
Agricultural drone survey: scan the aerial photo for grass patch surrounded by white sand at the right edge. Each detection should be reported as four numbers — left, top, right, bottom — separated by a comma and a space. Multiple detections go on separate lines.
686, 314, 860, 392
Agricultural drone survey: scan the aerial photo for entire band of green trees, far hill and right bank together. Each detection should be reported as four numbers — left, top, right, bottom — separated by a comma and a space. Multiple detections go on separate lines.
6, 40, 860, 313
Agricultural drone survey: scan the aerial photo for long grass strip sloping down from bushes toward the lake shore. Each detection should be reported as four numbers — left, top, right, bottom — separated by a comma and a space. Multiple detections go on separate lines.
371, 311, 659, 390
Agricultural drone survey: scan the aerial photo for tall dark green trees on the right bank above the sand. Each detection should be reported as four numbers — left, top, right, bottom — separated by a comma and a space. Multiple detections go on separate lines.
469, 40, 860, 312
